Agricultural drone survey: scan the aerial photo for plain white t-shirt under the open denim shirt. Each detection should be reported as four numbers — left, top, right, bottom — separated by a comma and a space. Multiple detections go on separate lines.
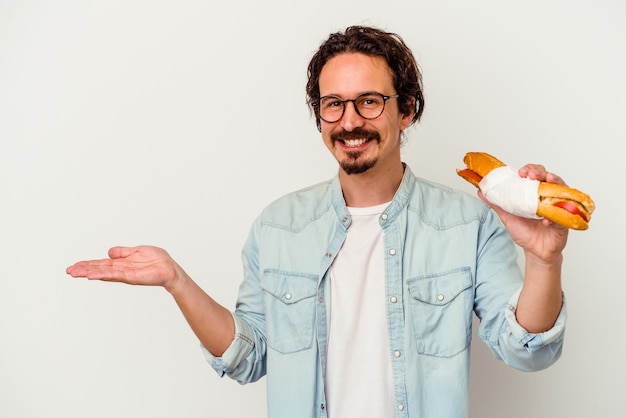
325, 203, 394, 418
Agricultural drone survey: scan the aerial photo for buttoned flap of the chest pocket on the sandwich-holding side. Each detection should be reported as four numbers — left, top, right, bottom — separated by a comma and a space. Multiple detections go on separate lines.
408, 269, 472, 306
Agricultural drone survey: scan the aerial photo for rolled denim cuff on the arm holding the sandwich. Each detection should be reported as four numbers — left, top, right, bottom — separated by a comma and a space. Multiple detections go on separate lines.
505, 289, 567, 353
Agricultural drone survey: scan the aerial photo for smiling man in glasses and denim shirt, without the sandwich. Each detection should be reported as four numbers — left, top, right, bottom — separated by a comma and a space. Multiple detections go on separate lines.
67, 27, 567, 418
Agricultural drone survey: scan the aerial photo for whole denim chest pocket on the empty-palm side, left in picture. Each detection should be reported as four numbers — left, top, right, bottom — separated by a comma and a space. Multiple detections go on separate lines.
261, 271, 318, 354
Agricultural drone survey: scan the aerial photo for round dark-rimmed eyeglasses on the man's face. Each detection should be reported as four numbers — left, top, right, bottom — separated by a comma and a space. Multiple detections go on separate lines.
319, 92, 400, 123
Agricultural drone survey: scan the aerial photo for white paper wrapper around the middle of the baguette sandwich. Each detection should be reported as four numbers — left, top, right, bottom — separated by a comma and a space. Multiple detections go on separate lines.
478, 166, 541, 219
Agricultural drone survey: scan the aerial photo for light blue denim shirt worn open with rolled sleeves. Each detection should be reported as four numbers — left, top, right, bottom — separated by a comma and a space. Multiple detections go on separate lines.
204, 167, 566, 418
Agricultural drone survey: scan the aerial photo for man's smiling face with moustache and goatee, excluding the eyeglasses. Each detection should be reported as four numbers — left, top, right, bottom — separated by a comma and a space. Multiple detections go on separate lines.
319, 53, 412, 174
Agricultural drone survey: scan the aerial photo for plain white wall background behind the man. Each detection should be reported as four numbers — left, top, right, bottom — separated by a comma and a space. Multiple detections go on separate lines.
0, 0, 626, 418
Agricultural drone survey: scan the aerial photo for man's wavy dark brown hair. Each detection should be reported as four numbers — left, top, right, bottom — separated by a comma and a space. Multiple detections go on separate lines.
306, 26, 424, 131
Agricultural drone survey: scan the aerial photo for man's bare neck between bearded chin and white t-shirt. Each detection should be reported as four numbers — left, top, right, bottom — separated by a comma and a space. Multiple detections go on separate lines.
339, 163, 404, 208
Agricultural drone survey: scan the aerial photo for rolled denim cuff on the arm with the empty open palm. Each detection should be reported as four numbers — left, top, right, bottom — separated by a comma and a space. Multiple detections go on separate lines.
200, 313, 254, 377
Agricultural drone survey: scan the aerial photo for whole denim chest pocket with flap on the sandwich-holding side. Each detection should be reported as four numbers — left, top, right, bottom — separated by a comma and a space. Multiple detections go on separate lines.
407, 268, 474, 357
